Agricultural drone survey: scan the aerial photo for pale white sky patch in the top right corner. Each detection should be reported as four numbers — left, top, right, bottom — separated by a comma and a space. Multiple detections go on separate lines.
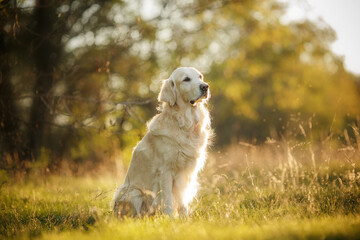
282, 0, 360, 75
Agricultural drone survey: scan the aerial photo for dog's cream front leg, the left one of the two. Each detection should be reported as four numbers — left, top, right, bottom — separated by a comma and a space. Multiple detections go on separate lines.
160, 171, 173, 215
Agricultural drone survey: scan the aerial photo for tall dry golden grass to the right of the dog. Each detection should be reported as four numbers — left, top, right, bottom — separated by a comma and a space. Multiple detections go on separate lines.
193, 126, 360, 222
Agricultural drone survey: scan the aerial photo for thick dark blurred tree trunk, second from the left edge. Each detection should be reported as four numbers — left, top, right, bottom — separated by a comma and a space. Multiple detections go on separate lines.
29, 0, 61, 159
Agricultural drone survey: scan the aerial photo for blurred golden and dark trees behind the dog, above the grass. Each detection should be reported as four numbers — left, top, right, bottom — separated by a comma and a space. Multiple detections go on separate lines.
0, 0, 360, 176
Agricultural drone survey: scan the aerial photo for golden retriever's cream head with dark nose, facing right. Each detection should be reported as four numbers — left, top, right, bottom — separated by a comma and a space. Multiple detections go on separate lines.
158, 67, 211, 106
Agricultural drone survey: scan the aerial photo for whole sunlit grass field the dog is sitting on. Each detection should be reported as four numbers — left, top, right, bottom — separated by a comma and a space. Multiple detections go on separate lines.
0, 142, 360, 240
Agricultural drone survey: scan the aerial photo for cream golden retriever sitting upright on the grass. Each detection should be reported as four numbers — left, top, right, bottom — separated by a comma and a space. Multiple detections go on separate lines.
112, 67, 210, 217
